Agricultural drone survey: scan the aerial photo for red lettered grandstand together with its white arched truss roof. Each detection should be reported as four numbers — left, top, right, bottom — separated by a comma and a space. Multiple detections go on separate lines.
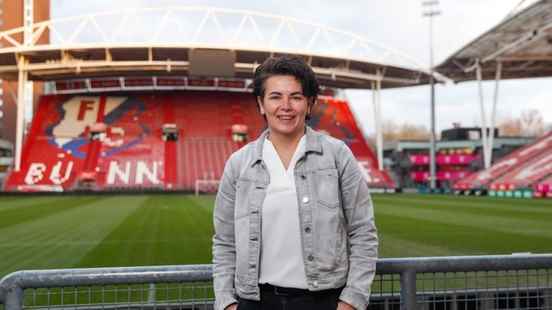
0, 7, 439, 191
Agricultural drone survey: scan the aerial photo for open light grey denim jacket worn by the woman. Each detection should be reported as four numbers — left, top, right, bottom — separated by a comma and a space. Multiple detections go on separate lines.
213, 127, 378, 310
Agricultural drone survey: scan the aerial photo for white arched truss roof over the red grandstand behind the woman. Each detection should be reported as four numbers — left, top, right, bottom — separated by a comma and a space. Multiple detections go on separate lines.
0, 7, 446, 88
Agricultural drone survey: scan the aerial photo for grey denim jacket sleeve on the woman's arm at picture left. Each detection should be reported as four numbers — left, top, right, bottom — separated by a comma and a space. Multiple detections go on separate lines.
213, 156, 237, 310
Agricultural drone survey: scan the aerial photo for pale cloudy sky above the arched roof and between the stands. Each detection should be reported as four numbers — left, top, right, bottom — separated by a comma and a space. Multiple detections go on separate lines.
51, 0, 552, 135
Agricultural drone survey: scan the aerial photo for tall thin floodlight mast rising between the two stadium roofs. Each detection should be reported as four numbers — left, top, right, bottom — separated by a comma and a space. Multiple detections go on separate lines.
422, 0, 441, 190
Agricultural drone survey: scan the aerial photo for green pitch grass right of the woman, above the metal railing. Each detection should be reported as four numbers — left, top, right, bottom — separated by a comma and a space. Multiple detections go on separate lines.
374, 195, 552, 257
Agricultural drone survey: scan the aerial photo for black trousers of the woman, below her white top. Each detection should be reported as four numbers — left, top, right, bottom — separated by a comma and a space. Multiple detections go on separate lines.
238, 288, 342, 310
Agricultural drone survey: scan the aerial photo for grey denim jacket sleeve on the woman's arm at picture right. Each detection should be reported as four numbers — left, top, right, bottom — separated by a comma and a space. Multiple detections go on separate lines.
337, 143, 378, 310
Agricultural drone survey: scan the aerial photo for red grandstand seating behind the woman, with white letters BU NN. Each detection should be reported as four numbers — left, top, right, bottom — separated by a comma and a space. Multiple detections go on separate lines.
5, 78, 394, 191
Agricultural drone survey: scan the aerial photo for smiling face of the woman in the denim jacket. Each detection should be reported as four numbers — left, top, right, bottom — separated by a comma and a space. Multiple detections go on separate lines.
257, 75, 310, 136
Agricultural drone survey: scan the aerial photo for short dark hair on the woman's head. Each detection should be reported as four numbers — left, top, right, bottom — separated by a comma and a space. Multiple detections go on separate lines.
253, 56, 320, 101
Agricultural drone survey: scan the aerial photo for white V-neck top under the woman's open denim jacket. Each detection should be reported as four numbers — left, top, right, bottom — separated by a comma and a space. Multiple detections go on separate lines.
259, 136, 308, 289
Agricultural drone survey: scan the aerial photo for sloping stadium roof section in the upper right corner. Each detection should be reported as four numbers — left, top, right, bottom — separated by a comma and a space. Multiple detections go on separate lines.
435, 0, 552, 82
